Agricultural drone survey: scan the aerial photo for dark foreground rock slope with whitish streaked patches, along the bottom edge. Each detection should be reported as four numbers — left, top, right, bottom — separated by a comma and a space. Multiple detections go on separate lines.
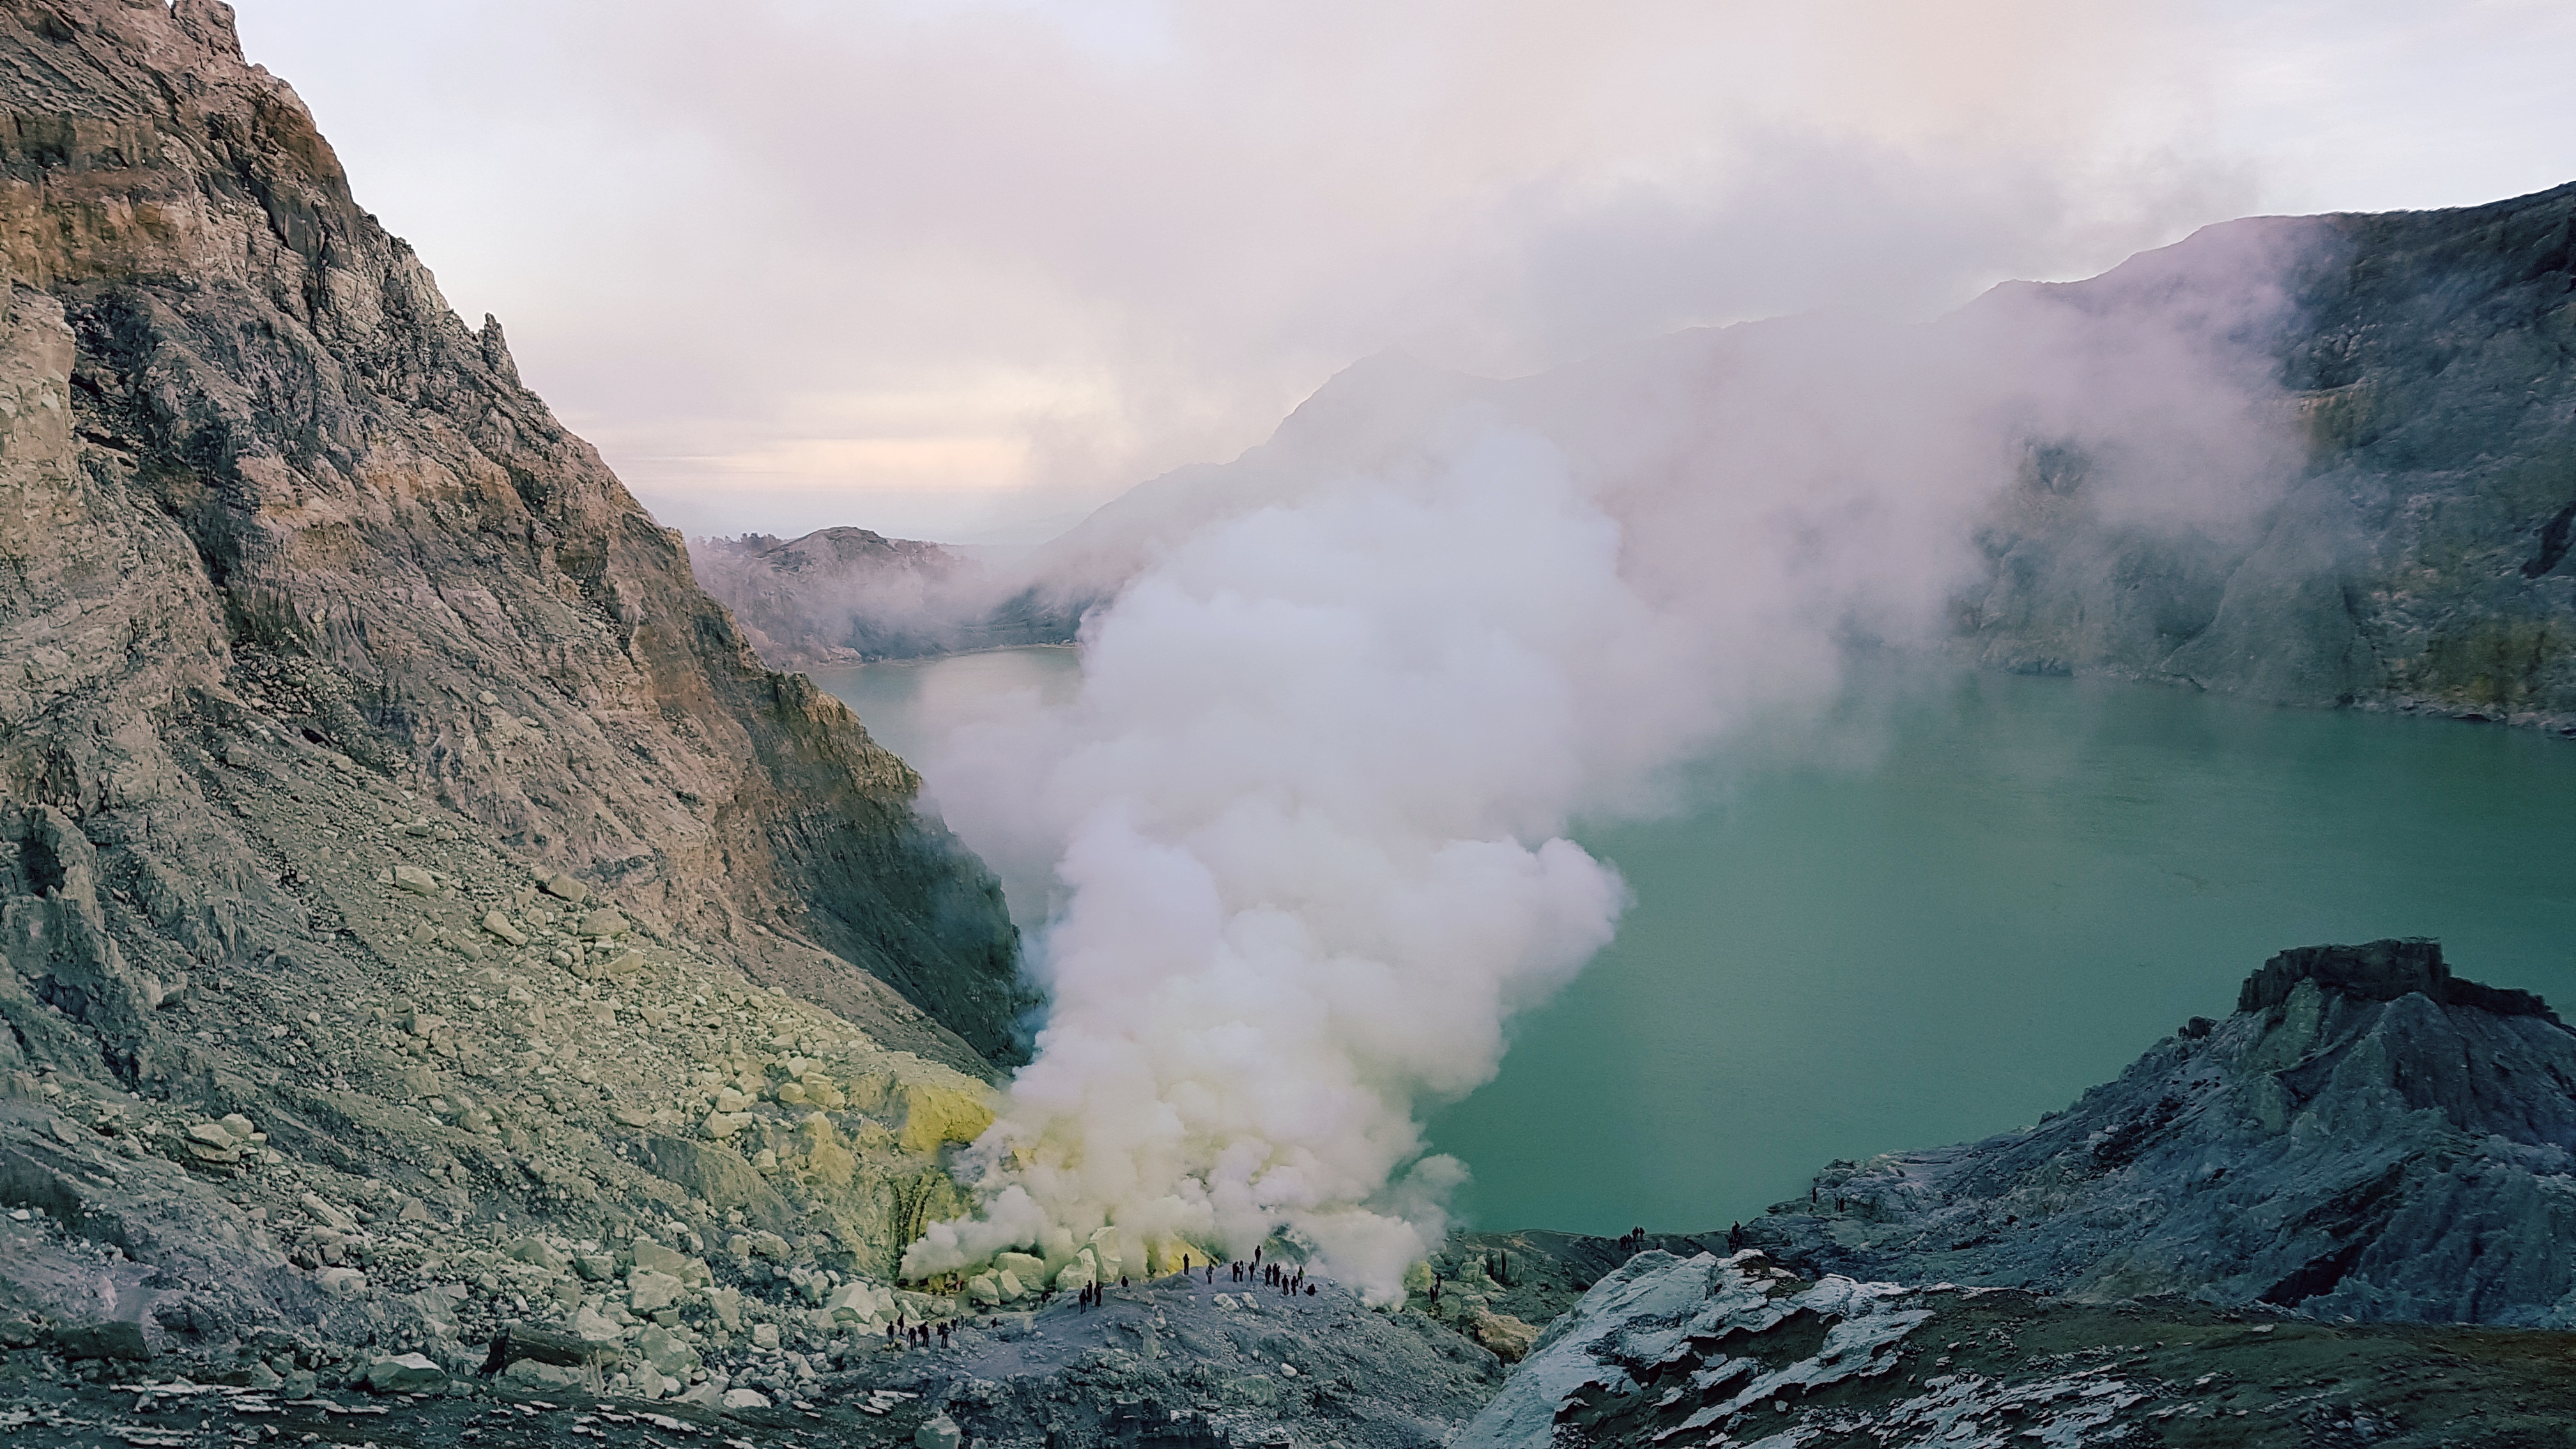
1453, 1253, 2576, 1449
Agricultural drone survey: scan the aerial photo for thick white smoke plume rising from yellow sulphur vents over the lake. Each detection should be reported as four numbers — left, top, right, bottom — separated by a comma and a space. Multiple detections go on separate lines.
904, 227, 2298, 1300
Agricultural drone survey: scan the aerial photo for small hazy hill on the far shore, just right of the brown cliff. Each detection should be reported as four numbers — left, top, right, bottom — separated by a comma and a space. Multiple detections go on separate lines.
691, 528, 1074, 670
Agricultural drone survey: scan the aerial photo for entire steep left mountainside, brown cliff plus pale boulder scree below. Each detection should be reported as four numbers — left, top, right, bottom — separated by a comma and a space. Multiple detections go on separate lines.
0, 0, 1077, 1397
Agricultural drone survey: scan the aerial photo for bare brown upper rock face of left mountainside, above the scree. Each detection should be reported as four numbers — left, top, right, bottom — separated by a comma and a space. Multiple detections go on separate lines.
0, 0, 1028, 1057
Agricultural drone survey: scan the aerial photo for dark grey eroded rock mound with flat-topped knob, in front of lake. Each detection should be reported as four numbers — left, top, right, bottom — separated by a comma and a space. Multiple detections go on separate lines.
1747, 941, 2576, 1328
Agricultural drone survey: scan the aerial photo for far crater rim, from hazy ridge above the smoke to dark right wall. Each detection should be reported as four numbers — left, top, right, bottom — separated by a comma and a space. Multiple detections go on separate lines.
783, 183, 2576, 732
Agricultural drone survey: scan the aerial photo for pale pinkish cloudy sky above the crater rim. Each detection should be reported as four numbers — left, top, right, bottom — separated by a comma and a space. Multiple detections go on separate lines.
240, 0, 2576, 539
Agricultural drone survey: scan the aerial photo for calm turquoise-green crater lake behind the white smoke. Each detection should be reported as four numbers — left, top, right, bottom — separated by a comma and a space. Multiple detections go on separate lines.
814, 650, 2576, 1232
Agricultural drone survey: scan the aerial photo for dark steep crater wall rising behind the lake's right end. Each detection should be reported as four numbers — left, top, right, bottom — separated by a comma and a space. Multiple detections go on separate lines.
1960, 186, 2576, 732
